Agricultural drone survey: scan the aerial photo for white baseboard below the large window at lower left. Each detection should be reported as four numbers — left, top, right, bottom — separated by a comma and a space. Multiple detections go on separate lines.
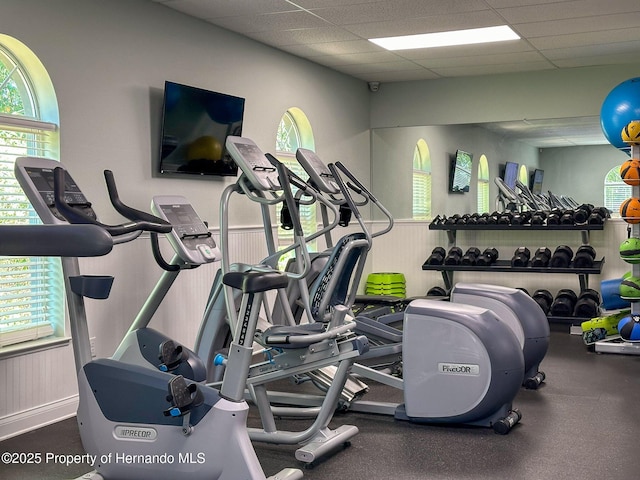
0, 395, 78, 441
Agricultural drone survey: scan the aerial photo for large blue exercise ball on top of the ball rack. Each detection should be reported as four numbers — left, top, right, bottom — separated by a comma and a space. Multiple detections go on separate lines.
600, 77, 640, 149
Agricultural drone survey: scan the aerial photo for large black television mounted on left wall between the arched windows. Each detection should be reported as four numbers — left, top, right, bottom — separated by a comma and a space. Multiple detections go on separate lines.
160, 81, 244, 176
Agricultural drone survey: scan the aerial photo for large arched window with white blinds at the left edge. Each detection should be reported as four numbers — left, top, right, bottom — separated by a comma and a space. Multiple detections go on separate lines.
0, 35, 64, 353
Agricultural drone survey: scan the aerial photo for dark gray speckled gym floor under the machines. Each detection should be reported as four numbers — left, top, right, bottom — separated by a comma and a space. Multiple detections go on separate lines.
0, 326, 640, 480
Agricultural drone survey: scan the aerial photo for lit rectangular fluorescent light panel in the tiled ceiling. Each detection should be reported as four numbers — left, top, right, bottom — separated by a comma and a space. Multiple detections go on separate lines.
369, 25, 520, 50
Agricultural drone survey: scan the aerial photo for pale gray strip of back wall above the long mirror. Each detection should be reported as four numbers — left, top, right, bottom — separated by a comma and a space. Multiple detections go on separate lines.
371, 63, 640, 128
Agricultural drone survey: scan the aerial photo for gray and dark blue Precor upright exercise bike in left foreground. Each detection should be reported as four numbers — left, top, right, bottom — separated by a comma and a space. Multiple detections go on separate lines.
13, 157, 302, 480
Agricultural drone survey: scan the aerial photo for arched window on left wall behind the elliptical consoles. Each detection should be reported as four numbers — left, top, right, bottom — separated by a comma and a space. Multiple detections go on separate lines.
276, 107, 317, 265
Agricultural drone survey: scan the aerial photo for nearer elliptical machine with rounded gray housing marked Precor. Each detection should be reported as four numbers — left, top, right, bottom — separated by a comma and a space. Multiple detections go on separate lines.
288, 152, 525, 434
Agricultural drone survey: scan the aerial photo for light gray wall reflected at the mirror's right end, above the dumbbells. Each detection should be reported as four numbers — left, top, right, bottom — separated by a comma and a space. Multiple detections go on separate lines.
540, 145, 629, 207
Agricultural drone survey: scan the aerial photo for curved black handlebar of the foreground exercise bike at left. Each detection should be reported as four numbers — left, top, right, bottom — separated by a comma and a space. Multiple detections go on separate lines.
53, 167, 171, 244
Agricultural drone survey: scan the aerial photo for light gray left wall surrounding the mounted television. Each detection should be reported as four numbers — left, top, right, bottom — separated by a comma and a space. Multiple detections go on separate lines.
0, 0, 370, 225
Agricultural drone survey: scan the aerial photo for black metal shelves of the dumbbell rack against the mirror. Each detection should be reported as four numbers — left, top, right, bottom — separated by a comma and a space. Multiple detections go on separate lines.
422, 223, 604, 324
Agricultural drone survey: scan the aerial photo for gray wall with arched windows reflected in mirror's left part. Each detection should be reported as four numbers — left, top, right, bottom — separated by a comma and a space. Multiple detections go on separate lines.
371, 125, 538, 219
